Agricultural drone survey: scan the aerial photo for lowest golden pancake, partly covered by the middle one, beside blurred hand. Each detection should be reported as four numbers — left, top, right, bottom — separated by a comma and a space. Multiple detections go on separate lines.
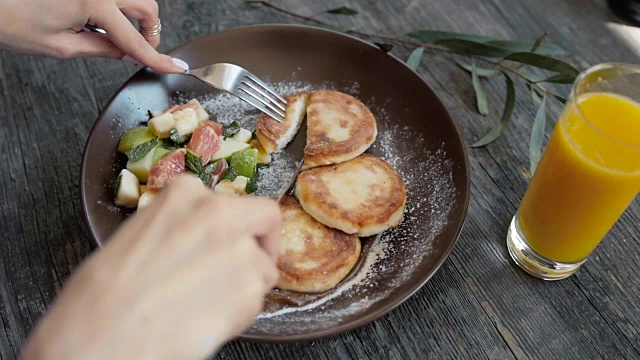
277, 196, 360, 293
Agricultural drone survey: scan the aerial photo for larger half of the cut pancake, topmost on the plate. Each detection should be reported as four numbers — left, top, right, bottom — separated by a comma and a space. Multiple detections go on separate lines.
303, 90, 377, 169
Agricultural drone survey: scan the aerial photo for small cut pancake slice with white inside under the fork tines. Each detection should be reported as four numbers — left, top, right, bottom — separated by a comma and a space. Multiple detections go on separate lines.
256, 93, 309, 154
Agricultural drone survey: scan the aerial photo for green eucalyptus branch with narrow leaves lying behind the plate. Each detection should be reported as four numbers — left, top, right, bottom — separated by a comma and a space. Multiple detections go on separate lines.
247, 0, 579, 171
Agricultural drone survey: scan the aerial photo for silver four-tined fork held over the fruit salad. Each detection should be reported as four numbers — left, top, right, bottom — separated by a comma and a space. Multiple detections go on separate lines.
183, 63, 287, 122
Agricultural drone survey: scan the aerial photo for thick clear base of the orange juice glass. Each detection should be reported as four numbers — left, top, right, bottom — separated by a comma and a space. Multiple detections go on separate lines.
507, 216, 587, 280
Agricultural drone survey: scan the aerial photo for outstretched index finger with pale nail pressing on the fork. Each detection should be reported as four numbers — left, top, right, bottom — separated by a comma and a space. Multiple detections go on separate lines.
90, 3, 187, 73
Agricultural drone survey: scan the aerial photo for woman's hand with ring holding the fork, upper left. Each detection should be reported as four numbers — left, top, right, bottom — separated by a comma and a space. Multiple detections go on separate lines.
0, 0, 188, 72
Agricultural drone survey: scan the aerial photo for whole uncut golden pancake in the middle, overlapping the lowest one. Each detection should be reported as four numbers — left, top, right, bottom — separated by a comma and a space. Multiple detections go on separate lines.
295, 154, 407, 236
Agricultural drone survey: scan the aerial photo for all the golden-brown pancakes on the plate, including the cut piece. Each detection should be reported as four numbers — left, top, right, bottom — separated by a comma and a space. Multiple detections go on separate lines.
256, 91, 406, 292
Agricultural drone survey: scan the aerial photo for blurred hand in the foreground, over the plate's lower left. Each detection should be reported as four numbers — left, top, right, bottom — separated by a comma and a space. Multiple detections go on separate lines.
24, 175, 280, 360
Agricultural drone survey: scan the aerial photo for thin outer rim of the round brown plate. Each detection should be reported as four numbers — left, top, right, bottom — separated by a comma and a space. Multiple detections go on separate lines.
80, 24, 471, 343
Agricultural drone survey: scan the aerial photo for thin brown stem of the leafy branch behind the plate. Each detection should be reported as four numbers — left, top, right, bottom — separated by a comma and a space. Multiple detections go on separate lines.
247, 0, 560, 97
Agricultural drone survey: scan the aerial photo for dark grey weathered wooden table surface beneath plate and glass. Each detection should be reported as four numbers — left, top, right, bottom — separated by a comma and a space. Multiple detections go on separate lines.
0, 0, 640, 360
